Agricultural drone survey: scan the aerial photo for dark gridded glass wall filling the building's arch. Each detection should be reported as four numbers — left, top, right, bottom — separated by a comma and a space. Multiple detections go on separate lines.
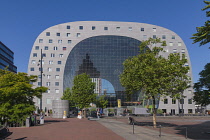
63, 35, 141, 105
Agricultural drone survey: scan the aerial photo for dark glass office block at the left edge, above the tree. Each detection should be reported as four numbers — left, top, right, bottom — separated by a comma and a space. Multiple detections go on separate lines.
0, 41, 17, 73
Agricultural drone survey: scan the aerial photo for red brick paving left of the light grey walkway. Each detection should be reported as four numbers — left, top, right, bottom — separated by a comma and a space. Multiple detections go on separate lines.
0, 118, 124, 140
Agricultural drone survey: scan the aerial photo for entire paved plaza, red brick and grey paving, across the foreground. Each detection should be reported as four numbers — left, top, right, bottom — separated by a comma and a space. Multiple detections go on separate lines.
2, 117, 210, 140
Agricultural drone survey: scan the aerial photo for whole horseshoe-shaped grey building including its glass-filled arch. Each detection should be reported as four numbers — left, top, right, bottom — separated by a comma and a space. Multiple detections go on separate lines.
28, 21, 195, 114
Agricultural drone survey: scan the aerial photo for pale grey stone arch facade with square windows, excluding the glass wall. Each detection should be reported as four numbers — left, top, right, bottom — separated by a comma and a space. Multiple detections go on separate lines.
28, 21, 195, 114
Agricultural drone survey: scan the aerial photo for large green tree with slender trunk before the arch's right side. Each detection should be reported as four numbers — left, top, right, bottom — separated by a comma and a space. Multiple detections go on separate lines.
120, 38, 190, 127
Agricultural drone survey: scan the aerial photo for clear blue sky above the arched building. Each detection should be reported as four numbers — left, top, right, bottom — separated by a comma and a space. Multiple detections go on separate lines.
0, 0, 210, 82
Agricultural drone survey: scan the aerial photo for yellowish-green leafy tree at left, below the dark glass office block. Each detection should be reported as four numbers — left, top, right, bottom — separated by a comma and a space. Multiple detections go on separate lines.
0, 69, 47, 125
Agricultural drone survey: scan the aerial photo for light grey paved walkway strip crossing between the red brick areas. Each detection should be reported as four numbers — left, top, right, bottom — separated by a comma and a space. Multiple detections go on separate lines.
98, 118, 191, 140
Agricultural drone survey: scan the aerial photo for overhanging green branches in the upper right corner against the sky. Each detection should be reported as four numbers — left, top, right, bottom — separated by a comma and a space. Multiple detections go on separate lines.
191, 1, 210, 46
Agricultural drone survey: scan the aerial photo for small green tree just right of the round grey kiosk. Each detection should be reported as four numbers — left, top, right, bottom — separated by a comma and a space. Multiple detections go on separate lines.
61, 88, 76, 108
